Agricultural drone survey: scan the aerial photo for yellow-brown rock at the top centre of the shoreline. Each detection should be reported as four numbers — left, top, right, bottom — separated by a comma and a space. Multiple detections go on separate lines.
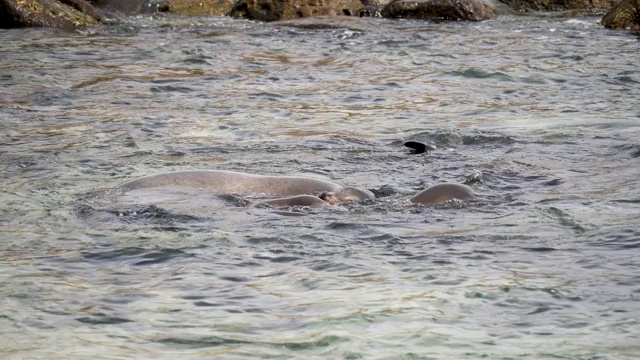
229, 0, 364, 21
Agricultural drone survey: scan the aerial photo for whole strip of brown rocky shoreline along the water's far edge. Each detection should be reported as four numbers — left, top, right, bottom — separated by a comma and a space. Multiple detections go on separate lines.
0, 0, 640, 30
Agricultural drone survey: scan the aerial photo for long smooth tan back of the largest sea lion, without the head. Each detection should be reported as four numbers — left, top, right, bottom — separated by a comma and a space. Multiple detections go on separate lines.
116, 170, 343, 197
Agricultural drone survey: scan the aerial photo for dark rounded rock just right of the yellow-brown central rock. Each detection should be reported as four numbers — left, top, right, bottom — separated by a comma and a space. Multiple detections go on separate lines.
382, 0, 496, 21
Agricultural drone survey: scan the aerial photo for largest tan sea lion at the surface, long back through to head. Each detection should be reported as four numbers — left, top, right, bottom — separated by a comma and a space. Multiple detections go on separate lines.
116, 170, 374, 206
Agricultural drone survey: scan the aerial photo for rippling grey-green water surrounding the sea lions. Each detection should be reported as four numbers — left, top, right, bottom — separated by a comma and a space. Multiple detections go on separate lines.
0, 12, 640, 359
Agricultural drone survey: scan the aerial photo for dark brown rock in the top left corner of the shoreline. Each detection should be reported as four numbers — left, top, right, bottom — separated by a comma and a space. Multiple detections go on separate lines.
0, 0, 101, 30
